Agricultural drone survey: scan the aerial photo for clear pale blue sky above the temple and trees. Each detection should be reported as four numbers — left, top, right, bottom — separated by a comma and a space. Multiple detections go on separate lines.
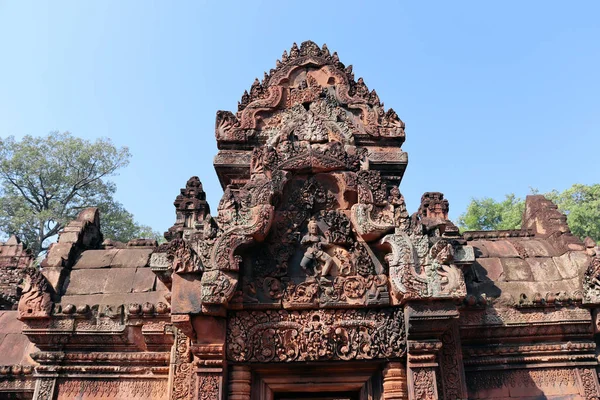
0, 0, 600, 231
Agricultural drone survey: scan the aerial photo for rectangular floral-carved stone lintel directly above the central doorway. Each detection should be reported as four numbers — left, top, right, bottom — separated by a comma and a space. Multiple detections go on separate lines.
227, 309, 406, 362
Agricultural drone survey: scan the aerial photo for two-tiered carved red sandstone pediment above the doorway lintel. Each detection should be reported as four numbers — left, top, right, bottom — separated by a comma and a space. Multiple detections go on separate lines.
159, 42, 474, 315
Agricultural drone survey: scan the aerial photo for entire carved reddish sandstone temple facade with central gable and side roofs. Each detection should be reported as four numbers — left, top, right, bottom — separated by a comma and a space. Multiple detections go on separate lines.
0, 42, 600, 400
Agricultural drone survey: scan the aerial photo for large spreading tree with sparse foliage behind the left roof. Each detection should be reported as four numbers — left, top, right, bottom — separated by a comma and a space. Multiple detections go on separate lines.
0, 132, 161, 254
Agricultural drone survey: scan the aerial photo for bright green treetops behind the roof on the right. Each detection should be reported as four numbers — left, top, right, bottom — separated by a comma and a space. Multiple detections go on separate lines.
458, 184, 600, 241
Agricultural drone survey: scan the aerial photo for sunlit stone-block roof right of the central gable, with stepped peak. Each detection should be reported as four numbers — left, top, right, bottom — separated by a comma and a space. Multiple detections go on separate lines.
464, 196, 596, 305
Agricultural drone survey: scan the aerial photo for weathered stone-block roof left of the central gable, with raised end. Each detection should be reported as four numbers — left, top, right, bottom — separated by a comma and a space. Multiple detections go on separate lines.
31, 209, 168, 310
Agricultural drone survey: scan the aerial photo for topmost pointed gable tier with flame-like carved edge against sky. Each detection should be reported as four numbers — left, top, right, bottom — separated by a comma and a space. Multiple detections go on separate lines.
215, 42, 407, 188
